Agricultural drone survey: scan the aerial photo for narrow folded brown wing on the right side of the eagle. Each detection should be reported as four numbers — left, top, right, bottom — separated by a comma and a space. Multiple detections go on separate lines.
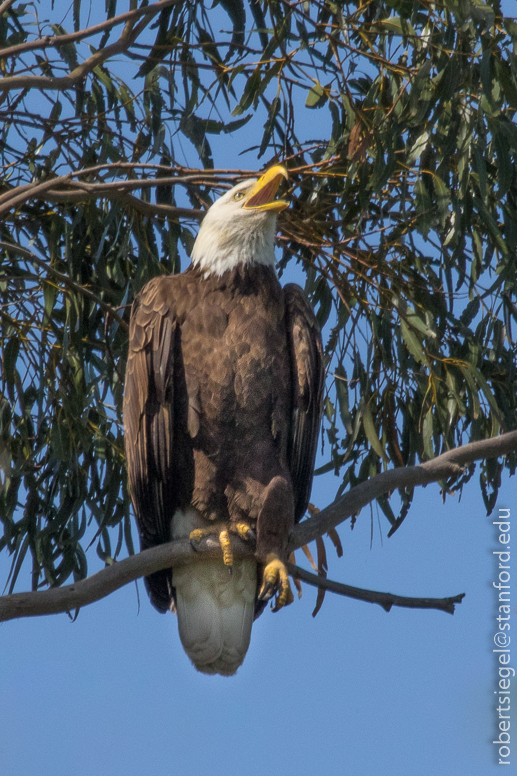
284, 283, 324, 522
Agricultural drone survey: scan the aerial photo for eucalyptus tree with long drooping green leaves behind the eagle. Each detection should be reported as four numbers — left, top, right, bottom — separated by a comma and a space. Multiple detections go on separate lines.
0, 0, 517, 608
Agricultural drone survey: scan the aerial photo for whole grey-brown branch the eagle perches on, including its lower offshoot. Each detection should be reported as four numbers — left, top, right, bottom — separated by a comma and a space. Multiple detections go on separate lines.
0, 431, 517, 622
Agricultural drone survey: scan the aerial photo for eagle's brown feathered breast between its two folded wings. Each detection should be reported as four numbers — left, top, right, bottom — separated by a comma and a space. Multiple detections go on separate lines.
171, 265, 292, 520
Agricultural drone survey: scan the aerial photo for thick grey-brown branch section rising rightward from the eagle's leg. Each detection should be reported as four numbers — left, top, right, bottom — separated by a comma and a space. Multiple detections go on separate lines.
289, 431, 517, 552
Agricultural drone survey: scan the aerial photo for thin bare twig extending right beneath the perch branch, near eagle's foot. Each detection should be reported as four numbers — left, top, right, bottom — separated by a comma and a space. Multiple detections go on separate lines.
287, 563, 465, 614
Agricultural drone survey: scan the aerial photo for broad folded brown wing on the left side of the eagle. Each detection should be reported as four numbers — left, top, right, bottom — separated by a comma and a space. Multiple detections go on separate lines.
124, 277, 191, 611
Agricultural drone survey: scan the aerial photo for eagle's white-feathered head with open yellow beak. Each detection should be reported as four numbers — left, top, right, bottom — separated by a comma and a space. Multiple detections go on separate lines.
192, 165, 289, 275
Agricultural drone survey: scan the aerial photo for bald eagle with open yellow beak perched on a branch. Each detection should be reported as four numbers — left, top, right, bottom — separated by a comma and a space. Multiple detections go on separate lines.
124, 166, 323, 676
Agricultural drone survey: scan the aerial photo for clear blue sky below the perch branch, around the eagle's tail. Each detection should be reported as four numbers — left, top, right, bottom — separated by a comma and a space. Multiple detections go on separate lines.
0, 3, 517, 776
